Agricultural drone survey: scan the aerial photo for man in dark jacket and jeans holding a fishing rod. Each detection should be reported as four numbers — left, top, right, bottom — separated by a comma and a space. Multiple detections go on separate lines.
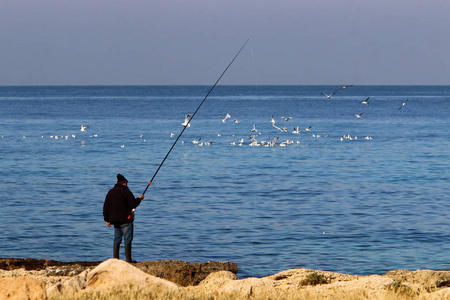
103, 174, 144, 263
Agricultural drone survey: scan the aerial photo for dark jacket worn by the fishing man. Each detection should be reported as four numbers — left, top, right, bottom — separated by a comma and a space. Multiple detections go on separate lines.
103, 183, 141, 225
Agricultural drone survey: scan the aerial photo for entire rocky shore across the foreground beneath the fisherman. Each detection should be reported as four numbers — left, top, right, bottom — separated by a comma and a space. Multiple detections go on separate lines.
0, 258, 450, 300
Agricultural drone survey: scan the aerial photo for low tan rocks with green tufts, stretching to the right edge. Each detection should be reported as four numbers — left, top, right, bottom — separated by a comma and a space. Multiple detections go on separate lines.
188, 269, 450, 300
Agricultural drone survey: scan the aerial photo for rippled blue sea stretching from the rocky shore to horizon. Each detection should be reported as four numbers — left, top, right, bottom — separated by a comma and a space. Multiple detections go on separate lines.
0, 86, 450, 278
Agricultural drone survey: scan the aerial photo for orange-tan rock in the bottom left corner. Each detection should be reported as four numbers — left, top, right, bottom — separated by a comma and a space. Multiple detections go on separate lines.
0, 276, 47, 300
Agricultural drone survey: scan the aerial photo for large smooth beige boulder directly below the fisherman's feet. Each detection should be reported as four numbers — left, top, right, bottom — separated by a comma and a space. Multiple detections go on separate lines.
86, 258, 179, 291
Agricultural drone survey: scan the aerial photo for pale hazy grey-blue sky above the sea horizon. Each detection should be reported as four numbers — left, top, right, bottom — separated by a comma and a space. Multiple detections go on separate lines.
0, 0, 450, 85
